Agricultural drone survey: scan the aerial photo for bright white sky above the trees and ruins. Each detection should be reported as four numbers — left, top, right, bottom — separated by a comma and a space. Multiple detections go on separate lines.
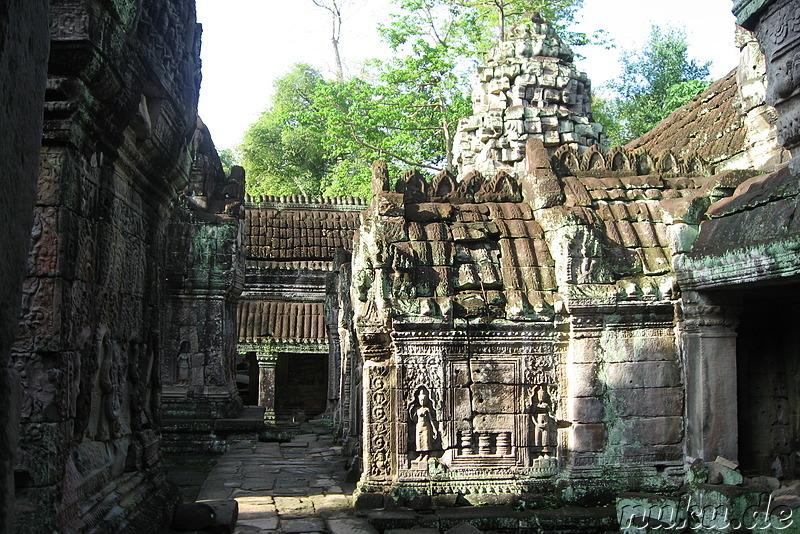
197, 0, 739, 149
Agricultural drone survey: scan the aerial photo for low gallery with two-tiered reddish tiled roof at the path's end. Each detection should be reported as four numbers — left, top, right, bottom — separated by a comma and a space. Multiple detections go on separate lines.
238, 196, 365, 424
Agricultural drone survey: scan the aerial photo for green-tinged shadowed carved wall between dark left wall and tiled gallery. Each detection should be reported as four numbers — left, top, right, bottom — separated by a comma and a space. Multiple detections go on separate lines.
160, 119, 244, 451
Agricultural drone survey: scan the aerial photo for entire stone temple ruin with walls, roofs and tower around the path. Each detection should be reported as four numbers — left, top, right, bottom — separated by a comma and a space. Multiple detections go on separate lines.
0, 0, 800, 533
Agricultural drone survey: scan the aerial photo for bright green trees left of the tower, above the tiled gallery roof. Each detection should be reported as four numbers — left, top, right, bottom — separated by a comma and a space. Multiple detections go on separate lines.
240, 0, 583, 197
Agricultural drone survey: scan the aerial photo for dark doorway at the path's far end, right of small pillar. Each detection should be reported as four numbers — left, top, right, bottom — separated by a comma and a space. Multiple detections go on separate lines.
275, 352, 328, 422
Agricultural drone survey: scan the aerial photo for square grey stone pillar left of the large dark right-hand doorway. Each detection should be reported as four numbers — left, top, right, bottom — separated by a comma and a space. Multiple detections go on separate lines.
679, 291, 739, 461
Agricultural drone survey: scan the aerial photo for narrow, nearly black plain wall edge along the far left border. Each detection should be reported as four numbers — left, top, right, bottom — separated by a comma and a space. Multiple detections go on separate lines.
0, 0, 50, 532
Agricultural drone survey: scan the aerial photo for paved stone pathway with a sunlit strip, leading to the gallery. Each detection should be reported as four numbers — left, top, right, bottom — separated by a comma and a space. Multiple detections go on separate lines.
197, 425, 378, 534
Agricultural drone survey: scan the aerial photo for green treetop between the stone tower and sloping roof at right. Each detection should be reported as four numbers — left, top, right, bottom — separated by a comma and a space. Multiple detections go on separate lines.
593, 25, 710, 145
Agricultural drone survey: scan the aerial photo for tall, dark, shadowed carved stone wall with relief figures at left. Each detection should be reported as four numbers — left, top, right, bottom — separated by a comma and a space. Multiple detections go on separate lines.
12, 0, 199, 532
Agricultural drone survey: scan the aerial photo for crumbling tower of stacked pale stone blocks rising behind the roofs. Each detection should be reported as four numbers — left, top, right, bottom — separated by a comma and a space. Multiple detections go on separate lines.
455, 14, 604, 175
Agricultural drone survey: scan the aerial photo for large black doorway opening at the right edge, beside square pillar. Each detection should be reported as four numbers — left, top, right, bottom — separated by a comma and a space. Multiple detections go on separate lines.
736, 285, 800, 479
